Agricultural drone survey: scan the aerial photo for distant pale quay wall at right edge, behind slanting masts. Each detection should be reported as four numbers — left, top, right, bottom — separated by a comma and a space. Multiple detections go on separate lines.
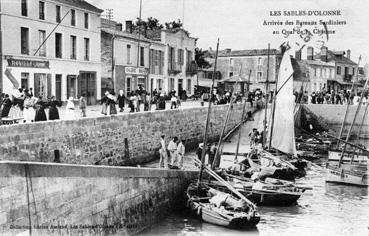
303, 104, 369, 136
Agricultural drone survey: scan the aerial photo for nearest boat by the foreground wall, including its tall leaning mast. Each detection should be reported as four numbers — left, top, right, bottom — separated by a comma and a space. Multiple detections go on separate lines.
186, 39, 260, 228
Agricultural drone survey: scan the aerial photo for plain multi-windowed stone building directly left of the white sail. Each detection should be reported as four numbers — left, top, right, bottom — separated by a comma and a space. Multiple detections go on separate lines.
213, 49, 281, 91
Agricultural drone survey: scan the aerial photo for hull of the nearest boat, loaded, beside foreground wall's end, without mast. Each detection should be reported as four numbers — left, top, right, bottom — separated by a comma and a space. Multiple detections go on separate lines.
186, 183, 260, 229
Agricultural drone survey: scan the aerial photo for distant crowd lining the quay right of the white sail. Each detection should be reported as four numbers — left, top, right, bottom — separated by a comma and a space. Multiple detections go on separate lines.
294, 89, 369, 105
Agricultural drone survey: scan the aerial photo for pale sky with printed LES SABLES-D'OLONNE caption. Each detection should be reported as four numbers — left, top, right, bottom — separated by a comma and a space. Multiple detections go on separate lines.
87, 0, 369, 66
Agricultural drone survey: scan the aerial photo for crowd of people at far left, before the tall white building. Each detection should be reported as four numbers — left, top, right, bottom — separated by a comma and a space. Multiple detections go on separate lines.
0, 88, 87, 123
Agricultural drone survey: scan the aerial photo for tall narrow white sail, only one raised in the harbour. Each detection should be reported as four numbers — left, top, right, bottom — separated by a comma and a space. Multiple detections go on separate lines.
271, 50, 296, 155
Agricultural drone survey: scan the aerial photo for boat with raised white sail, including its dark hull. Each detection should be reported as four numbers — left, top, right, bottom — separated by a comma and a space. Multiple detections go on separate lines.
252, 45, 306, 180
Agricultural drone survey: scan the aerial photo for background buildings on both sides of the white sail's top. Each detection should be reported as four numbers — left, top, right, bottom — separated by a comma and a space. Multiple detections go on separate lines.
197, 46, 365, 94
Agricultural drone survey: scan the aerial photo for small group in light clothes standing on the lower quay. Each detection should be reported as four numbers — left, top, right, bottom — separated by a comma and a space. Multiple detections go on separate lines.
159, 135, 186, 169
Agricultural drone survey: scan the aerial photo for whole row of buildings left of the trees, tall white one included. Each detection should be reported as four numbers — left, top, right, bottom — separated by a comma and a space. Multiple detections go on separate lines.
0, 0, 197, 105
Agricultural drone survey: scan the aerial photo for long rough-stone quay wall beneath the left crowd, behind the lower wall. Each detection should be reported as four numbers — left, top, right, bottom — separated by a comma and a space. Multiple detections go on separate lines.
0, 104, 253, 165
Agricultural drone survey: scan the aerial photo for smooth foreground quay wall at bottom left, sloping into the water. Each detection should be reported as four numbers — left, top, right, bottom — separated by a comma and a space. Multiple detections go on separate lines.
0, 161, 197, 235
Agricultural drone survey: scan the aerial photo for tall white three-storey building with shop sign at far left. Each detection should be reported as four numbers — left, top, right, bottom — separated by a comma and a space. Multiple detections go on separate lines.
1, 0, 102, 104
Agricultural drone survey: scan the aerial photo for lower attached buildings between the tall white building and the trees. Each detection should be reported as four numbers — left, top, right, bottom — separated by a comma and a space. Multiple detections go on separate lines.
101, 23, 196, 96
